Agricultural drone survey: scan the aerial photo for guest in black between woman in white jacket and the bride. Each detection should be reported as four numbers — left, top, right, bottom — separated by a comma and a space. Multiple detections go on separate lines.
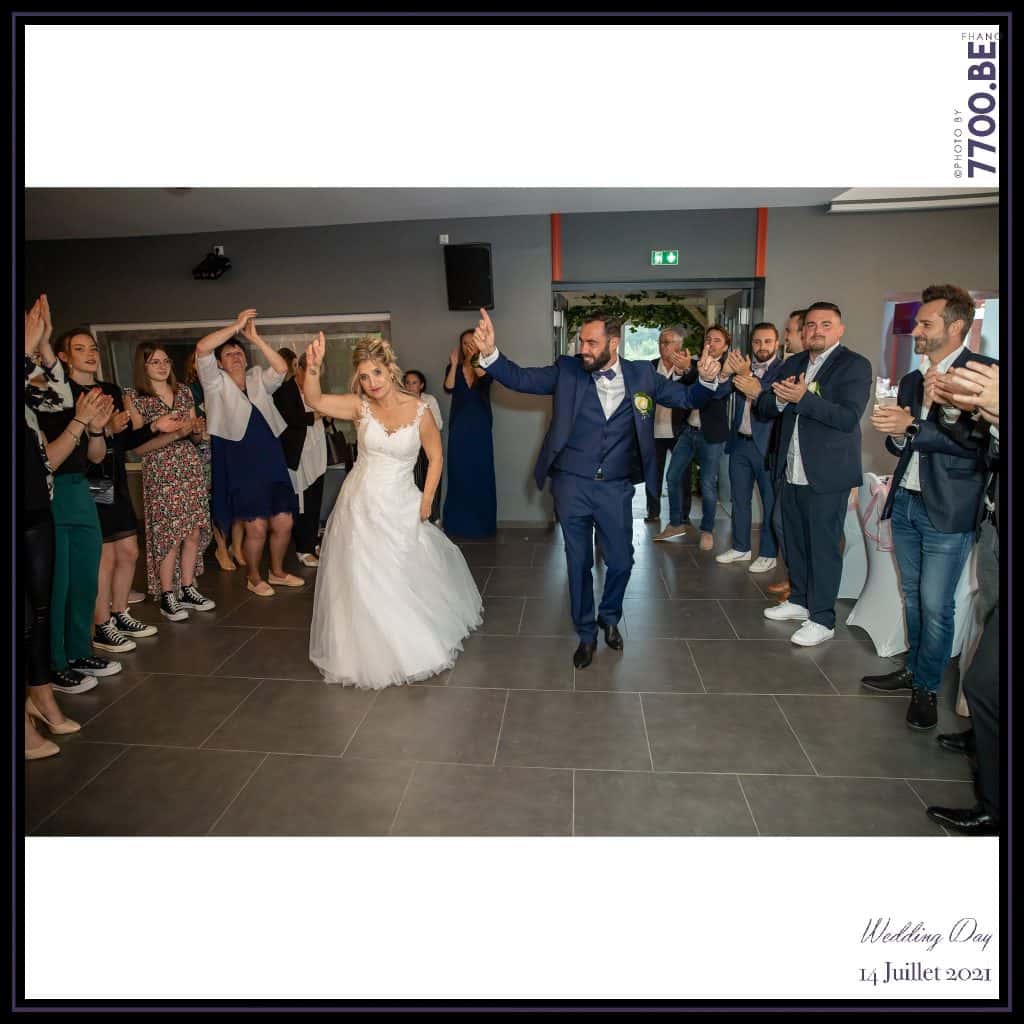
273, 352, 327, 568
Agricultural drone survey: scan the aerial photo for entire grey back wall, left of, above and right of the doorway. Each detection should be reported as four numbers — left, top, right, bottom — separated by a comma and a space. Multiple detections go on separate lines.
26, 199, 998, 522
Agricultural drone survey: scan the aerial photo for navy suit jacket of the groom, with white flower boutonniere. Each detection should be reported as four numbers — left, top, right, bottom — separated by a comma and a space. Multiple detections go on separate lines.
486, 354, 715, 493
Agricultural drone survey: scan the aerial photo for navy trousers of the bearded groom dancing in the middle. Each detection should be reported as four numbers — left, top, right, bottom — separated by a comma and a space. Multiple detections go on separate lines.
551, 472, 633, 643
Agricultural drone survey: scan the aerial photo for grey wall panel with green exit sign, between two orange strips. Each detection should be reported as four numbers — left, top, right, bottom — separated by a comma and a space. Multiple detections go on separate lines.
561, 210, 757, 282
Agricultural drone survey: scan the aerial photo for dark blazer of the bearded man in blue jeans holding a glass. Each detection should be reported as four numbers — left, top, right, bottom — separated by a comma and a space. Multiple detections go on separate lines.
882, 349, 995, 534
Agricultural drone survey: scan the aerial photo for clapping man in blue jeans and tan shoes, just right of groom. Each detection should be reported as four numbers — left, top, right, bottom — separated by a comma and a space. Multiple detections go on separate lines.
654, 326, 732, 551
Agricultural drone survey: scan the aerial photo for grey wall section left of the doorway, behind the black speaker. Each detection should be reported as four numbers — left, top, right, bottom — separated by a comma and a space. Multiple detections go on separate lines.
26, 216, 552, 522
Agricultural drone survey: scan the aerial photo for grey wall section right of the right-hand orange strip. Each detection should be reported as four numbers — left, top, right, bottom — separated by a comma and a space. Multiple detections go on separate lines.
765, 207, 999, 473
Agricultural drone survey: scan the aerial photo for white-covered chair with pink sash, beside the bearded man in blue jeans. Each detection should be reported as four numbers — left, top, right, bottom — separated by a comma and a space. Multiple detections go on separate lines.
846, 473, 909, 657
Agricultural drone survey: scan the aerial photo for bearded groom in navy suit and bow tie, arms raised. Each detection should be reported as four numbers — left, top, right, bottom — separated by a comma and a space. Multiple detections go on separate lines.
473, 309, 720, 669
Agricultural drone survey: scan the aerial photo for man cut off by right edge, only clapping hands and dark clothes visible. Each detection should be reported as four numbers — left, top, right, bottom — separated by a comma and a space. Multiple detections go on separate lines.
927, 360, 1002, 836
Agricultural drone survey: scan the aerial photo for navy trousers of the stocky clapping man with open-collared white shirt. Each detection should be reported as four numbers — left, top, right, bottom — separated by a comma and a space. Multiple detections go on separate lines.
782, 480, 850, 630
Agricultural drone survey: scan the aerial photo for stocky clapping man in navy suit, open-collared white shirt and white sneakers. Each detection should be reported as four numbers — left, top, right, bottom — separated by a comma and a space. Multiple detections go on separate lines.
754, 302, 871, 647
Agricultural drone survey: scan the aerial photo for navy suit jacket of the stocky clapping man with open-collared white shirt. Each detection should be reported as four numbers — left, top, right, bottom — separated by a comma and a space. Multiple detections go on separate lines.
754, 344, 872, 494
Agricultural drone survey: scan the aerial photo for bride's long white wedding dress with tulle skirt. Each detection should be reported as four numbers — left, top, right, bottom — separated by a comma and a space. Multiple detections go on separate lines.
309, 399, 483, 689
